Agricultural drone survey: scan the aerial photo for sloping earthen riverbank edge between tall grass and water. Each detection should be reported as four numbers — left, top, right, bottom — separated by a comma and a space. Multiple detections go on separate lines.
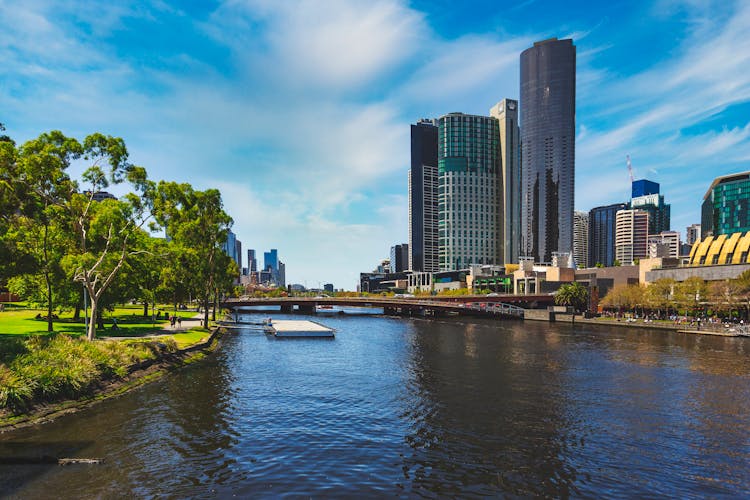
0, 327, 224, 433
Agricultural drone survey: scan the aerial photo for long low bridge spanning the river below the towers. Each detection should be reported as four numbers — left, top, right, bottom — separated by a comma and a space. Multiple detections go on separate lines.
221, 295, 554, 318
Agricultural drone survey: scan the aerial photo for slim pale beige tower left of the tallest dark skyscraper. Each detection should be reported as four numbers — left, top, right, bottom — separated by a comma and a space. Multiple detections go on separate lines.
490, 99, 521, 264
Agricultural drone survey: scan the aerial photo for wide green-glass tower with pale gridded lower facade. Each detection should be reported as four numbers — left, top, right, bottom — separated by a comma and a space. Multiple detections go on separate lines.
438, 113, 503, 271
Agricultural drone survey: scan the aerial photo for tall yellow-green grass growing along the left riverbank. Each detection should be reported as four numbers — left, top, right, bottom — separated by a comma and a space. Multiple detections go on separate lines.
0, 335, 176, 412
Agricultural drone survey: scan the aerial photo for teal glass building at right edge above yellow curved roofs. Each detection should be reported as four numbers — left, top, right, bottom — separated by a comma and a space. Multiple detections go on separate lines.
701, 172, 750, 238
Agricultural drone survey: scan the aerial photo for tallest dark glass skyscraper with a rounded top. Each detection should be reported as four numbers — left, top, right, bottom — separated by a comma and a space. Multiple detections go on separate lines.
520, 38, 576, 262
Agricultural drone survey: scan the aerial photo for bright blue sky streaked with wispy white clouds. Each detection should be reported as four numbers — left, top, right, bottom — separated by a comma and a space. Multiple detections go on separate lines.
0, 0, 750, 289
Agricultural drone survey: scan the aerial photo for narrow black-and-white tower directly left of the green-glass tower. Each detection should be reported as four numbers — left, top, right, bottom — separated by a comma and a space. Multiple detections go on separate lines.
407, 119, 438, 272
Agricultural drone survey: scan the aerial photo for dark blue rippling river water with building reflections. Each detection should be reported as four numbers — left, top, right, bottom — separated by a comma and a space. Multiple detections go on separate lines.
0, 313, 750, 498
